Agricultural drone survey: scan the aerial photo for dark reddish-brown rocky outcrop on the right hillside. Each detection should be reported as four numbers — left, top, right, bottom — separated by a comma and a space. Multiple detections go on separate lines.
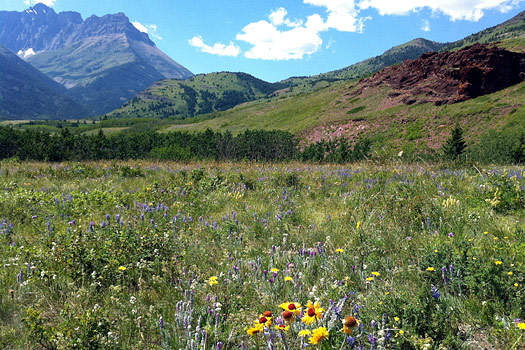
353, 44, 525, 105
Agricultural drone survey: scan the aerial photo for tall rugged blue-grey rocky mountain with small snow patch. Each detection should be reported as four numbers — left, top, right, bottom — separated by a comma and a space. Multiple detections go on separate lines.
0, 3, 192, 115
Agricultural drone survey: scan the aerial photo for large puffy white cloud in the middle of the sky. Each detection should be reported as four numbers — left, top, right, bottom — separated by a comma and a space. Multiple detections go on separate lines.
236, 8, 327, 60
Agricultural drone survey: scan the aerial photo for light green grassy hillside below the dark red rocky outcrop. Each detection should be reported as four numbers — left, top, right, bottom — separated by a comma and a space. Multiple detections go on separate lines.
159, 38, 525, 159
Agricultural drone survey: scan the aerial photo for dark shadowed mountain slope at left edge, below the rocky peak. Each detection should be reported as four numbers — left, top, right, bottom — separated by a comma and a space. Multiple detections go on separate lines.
0, 44, 85, 119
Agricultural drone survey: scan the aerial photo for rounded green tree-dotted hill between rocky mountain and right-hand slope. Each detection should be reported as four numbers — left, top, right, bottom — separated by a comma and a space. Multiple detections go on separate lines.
109, 72, 287, 119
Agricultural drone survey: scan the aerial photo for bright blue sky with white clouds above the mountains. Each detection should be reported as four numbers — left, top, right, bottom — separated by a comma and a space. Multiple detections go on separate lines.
0, 0, 525, 82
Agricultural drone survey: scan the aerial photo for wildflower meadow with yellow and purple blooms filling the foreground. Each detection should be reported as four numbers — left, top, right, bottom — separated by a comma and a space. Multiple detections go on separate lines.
0, 161, 525, 350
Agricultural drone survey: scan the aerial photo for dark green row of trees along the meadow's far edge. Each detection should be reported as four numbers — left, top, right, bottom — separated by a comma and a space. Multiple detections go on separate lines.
0, 126, 376, 162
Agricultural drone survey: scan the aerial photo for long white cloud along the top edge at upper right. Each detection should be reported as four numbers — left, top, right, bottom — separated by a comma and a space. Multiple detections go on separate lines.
354, 0, 524, 21
